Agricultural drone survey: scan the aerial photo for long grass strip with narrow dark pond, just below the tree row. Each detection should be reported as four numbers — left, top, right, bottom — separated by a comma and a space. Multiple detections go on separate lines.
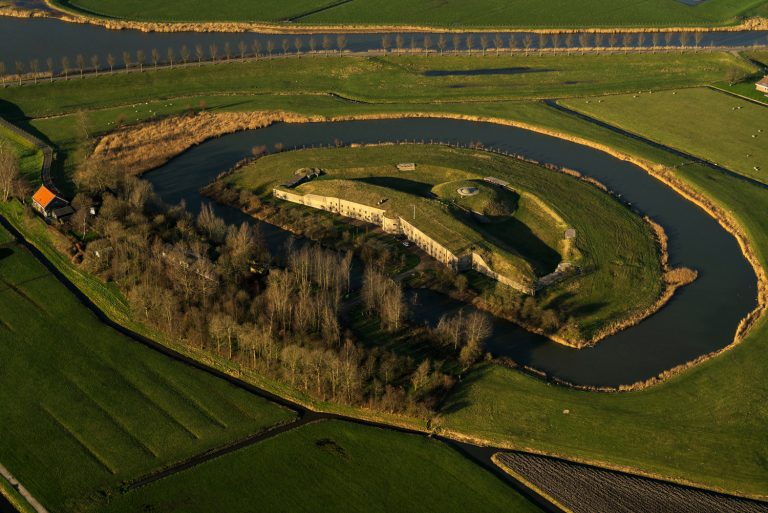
0, 52, 757, 122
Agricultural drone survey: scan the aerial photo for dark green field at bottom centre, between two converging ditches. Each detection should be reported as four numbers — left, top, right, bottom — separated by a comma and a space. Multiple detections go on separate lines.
103, 421, 540, 513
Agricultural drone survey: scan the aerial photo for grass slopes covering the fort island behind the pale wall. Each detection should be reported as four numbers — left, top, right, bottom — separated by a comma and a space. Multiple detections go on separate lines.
228, 145, 661, 341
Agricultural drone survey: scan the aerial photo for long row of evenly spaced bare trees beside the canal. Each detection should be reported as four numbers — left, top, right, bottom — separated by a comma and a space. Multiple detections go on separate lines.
0, 32, 724, 86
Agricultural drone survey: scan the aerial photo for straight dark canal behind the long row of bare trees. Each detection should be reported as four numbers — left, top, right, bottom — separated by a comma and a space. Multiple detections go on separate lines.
0, 16, 768, 74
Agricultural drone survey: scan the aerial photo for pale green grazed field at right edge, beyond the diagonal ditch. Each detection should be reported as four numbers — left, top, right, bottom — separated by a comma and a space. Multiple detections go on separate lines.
561, 88, 768, 183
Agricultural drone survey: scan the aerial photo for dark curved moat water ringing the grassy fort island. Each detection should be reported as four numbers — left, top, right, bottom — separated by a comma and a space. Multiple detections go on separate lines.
145, 119, 757, 386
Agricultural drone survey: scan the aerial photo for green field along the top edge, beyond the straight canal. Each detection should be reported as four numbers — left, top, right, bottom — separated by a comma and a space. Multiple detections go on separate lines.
51, 0, 766, 28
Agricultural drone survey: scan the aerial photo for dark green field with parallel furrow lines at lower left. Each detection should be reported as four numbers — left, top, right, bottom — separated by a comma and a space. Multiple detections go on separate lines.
0, 234, 293, 512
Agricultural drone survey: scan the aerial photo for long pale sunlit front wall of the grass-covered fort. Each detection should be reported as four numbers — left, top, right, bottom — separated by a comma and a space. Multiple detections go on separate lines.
272, 188, 534, 294
